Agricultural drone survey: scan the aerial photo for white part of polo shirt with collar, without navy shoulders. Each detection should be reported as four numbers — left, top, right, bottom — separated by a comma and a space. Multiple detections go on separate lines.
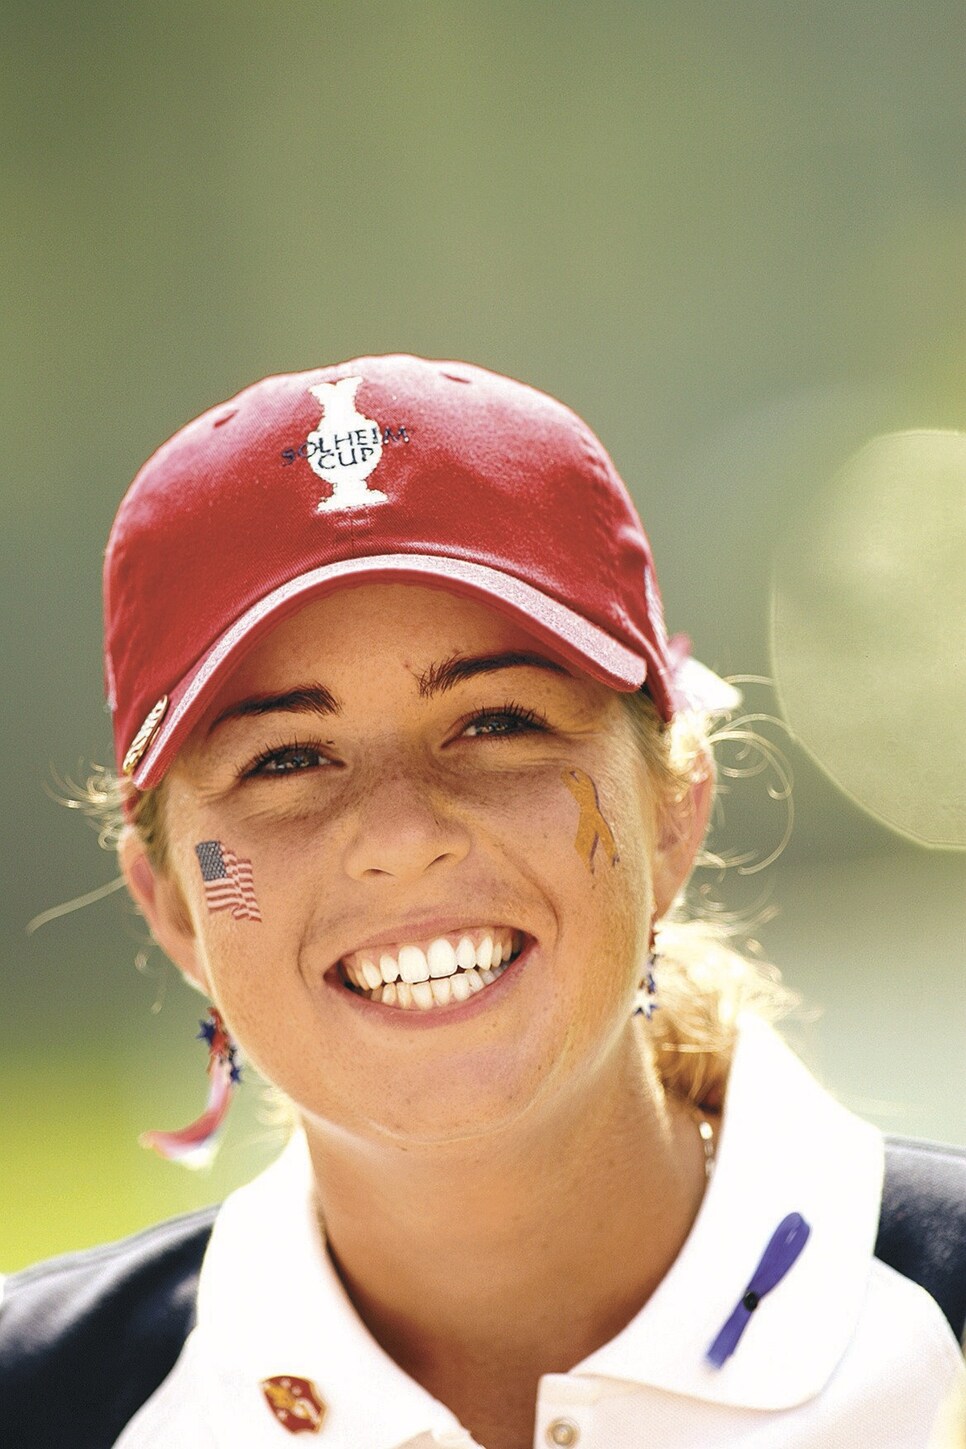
111, 1020, 966, 1449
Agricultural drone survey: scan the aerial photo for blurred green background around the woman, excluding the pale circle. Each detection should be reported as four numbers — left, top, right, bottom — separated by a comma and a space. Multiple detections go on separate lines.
0, 0, 966, 1271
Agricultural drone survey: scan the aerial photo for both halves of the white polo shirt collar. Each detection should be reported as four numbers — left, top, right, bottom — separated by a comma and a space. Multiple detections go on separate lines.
186, 1019, 883, 1449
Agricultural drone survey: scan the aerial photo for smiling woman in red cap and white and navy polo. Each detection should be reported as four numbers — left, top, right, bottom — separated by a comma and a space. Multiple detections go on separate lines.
0, 356, 963, 1449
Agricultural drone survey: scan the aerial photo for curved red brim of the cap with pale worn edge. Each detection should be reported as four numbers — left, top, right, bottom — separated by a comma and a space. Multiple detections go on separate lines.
130, 554, 673, 790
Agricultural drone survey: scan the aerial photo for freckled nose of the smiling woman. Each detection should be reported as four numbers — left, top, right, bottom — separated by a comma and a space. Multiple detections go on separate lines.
345, 764, 471, 884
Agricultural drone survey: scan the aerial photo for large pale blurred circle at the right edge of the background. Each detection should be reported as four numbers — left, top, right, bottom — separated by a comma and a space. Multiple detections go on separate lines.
770, 430, 966, 848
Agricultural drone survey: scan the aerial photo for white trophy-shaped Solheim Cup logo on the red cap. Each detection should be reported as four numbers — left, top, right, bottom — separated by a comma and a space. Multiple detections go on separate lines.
306, 377, 387, 513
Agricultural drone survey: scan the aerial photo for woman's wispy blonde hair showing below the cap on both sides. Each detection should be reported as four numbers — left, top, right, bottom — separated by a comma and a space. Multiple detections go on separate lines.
67, 691, 798, 1110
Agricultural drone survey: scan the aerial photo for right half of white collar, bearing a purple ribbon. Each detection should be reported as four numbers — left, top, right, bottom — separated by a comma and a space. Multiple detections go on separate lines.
571, 1017, 883, 1408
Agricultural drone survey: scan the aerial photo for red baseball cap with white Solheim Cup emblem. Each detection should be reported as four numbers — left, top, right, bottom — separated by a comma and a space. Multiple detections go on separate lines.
104, 355, 739, 790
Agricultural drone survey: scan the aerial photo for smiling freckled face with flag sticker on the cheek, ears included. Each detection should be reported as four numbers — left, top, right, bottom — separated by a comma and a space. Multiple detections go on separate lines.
122, 584, 698, 1142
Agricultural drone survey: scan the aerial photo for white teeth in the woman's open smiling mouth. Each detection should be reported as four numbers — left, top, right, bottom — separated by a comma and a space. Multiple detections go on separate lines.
339, 926, 527, 1011
